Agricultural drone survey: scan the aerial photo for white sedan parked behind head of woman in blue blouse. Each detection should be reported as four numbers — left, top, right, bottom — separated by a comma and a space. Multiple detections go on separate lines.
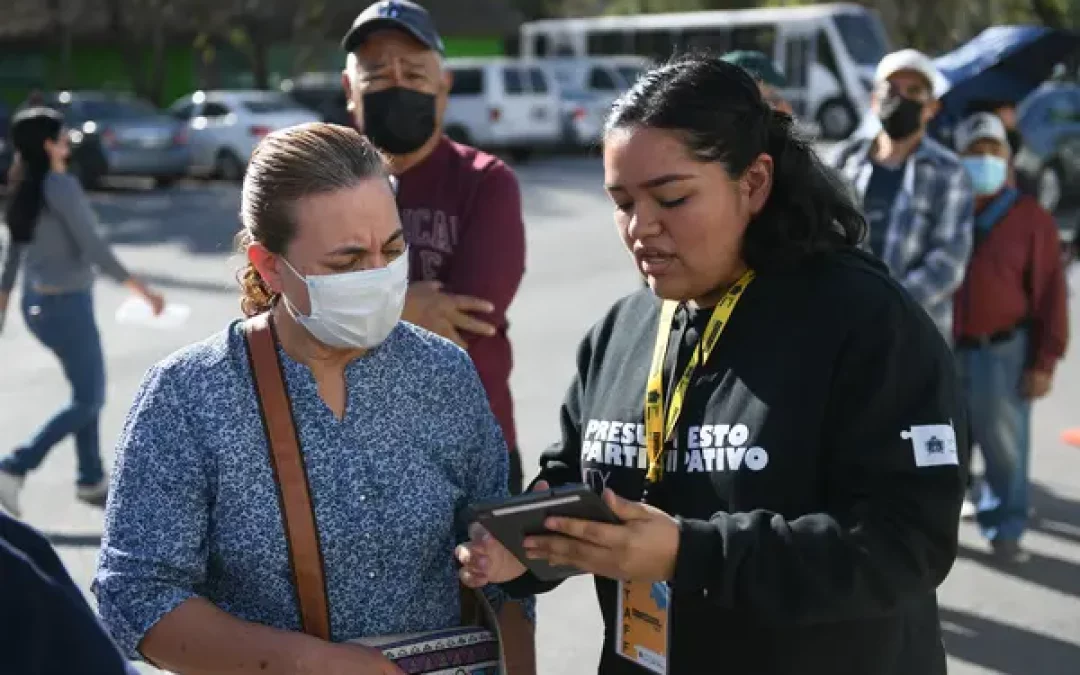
170, 90, 320, 180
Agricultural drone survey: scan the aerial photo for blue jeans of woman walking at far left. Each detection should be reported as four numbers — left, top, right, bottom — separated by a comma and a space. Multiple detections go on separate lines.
0, 291, 105, 485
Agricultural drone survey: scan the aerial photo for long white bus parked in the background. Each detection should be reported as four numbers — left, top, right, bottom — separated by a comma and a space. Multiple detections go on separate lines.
521, 3, 889, 138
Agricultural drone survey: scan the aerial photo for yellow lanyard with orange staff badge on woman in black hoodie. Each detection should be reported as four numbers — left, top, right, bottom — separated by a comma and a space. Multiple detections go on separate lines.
616, 270, 754, 675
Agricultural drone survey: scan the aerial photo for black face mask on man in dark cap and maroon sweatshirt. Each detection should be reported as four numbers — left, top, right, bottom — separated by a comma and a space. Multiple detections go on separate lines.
363, 86, 435, 154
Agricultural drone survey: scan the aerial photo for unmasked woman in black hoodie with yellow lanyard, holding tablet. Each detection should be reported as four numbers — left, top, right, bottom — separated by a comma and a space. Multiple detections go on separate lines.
458, 56, 966, 675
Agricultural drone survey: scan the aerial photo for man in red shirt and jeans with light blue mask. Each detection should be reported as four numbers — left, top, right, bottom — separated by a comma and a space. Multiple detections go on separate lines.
954, 112, 1068, 562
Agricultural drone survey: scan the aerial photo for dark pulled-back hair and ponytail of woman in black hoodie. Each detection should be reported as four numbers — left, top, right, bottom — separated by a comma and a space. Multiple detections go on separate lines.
606, 54, 866, 270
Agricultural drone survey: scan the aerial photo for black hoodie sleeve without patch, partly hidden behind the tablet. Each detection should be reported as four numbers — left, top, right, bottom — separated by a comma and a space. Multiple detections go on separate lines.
501, 332, 593, 598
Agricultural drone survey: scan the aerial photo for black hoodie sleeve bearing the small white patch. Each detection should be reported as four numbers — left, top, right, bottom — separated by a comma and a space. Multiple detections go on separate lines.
673, 295, 967, 623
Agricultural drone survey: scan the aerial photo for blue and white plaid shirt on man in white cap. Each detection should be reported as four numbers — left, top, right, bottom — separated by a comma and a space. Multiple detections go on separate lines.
829, 137, 974, 342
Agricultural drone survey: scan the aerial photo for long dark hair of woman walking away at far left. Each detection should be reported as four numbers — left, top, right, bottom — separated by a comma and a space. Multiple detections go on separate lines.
5, 108, 64, 244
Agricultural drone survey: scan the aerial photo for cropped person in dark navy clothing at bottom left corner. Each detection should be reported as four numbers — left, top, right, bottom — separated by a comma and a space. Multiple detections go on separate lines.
0, 512, 137, 675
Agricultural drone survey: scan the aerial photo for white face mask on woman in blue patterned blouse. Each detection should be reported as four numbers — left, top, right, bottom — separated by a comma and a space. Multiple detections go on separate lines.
282, 251, 408, 349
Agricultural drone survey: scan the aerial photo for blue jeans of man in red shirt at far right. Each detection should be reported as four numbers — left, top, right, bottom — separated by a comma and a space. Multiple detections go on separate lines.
957, 330, 1031, 541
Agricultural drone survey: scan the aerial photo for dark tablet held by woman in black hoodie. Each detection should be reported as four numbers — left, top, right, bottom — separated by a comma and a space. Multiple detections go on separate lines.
470, 485, 620, 581
